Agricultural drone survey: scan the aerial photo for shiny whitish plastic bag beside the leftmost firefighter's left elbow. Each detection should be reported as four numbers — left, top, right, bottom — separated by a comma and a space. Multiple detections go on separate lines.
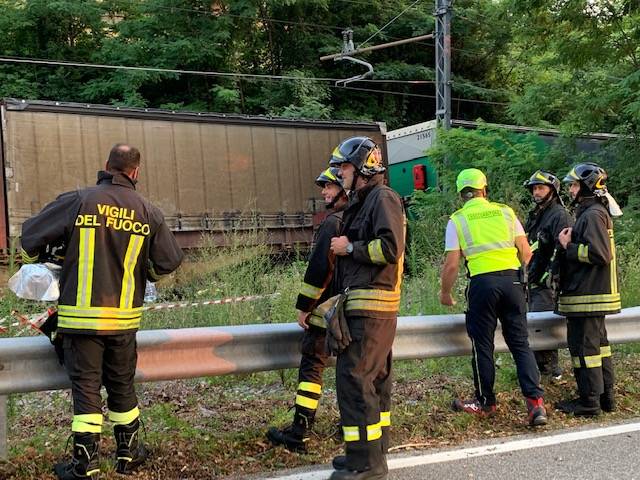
9, 263, 62, 302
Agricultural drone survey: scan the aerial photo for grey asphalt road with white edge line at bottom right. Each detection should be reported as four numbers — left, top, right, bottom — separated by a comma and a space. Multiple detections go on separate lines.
266, 419, 640, 480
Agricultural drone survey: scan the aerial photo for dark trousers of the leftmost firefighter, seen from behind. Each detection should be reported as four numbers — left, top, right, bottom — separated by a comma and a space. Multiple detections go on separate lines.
62, 333, 139, 433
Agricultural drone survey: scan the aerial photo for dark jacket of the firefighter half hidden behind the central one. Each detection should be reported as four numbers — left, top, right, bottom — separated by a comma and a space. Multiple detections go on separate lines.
296, 212, 342, 328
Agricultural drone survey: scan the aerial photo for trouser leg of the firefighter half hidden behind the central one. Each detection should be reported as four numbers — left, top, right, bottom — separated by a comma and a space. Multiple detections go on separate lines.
296, 324, 328, 421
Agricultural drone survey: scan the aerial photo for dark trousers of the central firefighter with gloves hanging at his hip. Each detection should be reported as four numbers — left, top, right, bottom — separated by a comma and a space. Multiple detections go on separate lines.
336, 317, 397, 471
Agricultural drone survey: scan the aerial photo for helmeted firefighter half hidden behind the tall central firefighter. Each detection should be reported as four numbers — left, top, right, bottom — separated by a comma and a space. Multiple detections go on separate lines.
267, 167, 347, 452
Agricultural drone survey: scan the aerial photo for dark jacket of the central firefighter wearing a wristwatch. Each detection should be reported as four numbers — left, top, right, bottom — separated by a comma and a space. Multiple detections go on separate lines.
336, 175, 406, 318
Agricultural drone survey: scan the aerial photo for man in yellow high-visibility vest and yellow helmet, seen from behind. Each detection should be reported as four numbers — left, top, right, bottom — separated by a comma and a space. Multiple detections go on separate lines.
440, 168, 547, 426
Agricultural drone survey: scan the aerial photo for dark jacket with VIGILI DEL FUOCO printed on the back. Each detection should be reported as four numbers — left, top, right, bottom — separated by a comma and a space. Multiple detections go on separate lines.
21, 172, 183, 335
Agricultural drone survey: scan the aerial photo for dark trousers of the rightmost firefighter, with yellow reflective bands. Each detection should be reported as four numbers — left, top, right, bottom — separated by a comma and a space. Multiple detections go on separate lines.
567, 316, 615, 405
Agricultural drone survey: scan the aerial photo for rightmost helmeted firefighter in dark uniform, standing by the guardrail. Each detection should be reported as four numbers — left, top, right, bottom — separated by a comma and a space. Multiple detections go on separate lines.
556, 163, 621, 416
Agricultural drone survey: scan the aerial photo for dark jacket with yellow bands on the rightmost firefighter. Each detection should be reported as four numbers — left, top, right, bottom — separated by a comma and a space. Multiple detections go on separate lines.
556, 197, 620, 317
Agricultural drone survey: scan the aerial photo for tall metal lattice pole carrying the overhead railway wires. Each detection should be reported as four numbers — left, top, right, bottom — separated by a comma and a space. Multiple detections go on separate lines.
435, 0, 451, 130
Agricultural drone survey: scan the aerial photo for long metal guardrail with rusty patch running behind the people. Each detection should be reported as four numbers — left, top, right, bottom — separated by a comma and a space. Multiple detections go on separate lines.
0, 307, 640, 458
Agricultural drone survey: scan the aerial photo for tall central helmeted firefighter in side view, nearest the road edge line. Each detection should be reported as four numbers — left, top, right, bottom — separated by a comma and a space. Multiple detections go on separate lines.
330, 137, 406, 480
